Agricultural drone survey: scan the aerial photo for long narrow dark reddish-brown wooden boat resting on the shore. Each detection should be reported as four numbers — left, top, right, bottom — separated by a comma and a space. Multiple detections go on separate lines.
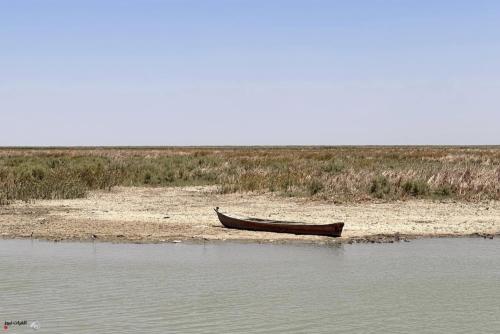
215, 207, 344, 237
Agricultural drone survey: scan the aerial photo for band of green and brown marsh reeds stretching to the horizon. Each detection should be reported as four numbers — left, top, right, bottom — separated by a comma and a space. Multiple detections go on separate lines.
0, 146, 500, 203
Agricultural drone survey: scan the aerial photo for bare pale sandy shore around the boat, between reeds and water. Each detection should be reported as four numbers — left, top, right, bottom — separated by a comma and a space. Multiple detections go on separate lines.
0, 187, 500, 243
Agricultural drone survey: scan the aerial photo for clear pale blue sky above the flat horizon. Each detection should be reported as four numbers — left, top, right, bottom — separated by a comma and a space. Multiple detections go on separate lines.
0, 0, 500, 146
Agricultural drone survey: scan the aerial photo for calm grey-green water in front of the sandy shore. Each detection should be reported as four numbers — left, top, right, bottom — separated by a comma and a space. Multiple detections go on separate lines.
0, 239, 500, 333
